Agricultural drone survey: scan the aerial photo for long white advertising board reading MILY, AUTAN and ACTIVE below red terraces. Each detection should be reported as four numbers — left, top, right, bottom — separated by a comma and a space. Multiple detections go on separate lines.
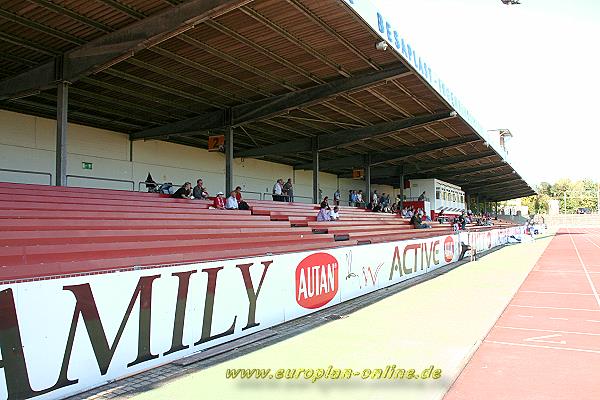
0, 231, 510, 400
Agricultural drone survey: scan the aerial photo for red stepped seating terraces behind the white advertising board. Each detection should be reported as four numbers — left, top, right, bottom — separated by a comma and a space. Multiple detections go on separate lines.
0, 183, 516, 281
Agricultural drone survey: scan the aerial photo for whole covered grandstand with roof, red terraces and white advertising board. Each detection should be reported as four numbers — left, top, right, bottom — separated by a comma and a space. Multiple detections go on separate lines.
0, 0, 535, 399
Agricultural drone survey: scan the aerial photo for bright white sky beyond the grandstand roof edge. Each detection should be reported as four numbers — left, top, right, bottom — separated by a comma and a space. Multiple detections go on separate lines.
373, 0, 600, 184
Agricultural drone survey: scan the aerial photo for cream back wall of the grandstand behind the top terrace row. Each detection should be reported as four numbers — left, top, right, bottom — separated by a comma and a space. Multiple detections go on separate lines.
0, 110, 397, 202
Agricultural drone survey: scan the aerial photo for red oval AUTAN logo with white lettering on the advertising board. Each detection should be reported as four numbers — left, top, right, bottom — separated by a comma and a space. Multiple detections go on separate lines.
296, 253, 339, 309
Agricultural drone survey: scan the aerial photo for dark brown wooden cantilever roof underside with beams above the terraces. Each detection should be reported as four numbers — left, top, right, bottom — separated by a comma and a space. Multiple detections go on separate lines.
0, 0, 534, 200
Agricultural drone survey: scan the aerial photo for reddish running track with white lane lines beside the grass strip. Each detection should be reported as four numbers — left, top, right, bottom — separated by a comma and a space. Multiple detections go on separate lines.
444, 228, 600, 400
